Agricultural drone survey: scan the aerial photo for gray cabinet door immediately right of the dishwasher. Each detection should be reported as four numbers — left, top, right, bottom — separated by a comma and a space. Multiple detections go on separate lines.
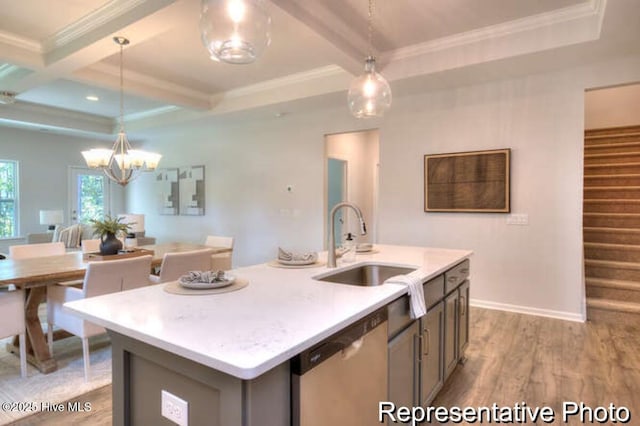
388, 321, 420, 407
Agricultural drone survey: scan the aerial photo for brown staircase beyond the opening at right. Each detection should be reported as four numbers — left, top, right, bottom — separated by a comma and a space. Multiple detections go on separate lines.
583, 126, 640, 321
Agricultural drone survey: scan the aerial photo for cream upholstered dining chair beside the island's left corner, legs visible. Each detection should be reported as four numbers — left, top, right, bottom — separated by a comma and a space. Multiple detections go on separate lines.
47, 256, 151, 381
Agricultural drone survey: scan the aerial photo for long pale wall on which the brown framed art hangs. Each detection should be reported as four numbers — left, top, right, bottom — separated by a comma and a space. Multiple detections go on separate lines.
129, 53, 640, 319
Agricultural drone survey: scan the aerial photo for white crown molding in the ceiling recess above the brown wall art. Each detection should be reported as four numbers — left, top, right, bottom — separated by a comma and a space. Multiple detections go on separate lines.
381, 0, 607, 63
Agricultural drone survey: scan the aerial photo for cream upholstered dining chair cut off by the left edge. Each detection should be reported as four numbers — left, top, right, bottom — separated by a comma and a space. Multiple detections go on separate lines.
0, 287, 27, 377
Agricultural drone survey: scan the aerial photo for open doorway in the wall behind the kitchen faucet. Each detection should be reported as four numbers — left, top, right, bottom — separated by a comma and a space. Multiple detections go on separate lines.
323, 129, 380, 247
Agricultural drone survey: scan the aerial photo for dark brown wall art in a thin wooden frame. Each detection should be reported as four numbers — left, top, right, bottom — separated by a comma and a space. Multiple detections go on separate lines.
424, 148, 511, 213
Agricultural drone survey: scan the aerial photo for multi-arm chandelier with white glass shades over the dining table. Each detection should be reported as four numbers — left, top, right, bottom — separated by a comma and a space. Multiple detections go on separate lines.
82, 37, 162, 186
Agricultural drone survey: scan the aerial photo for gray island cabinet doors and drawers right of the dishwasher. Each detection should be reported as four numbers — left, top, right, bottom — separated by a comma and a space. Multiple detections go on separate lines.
387, 260, 469, 407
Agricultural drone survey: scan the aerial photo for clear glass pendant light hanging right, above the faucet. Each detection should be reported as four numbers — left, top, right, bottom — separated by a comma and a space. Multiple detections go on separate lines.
347, 0, 391, 118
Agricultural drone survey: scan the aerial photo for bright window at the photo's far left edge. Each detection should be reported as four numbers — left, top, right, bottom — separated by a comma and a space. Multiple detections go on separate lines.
0, 160, 18, 238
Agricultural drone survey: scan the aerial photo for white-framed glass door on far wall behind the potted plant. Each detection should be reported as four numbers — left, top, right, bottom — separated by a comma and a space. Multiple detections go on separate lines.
69, 167, 111, 223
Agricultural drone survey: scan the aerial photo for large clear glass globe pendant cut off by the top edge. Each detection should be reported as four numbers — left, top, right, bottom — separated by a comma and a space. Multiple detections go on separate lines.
200, 0, 271, 64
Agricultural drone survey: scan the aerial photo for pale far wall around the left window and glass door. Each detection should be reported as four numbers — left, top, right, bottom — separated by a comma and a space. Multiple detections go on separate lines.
0, 127, 124, 252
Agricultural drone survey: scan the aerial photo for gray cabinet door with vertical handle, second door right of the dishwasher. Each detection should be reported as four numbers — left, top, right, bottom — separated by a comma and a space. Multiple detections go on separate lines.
420, 302, 444, 406
